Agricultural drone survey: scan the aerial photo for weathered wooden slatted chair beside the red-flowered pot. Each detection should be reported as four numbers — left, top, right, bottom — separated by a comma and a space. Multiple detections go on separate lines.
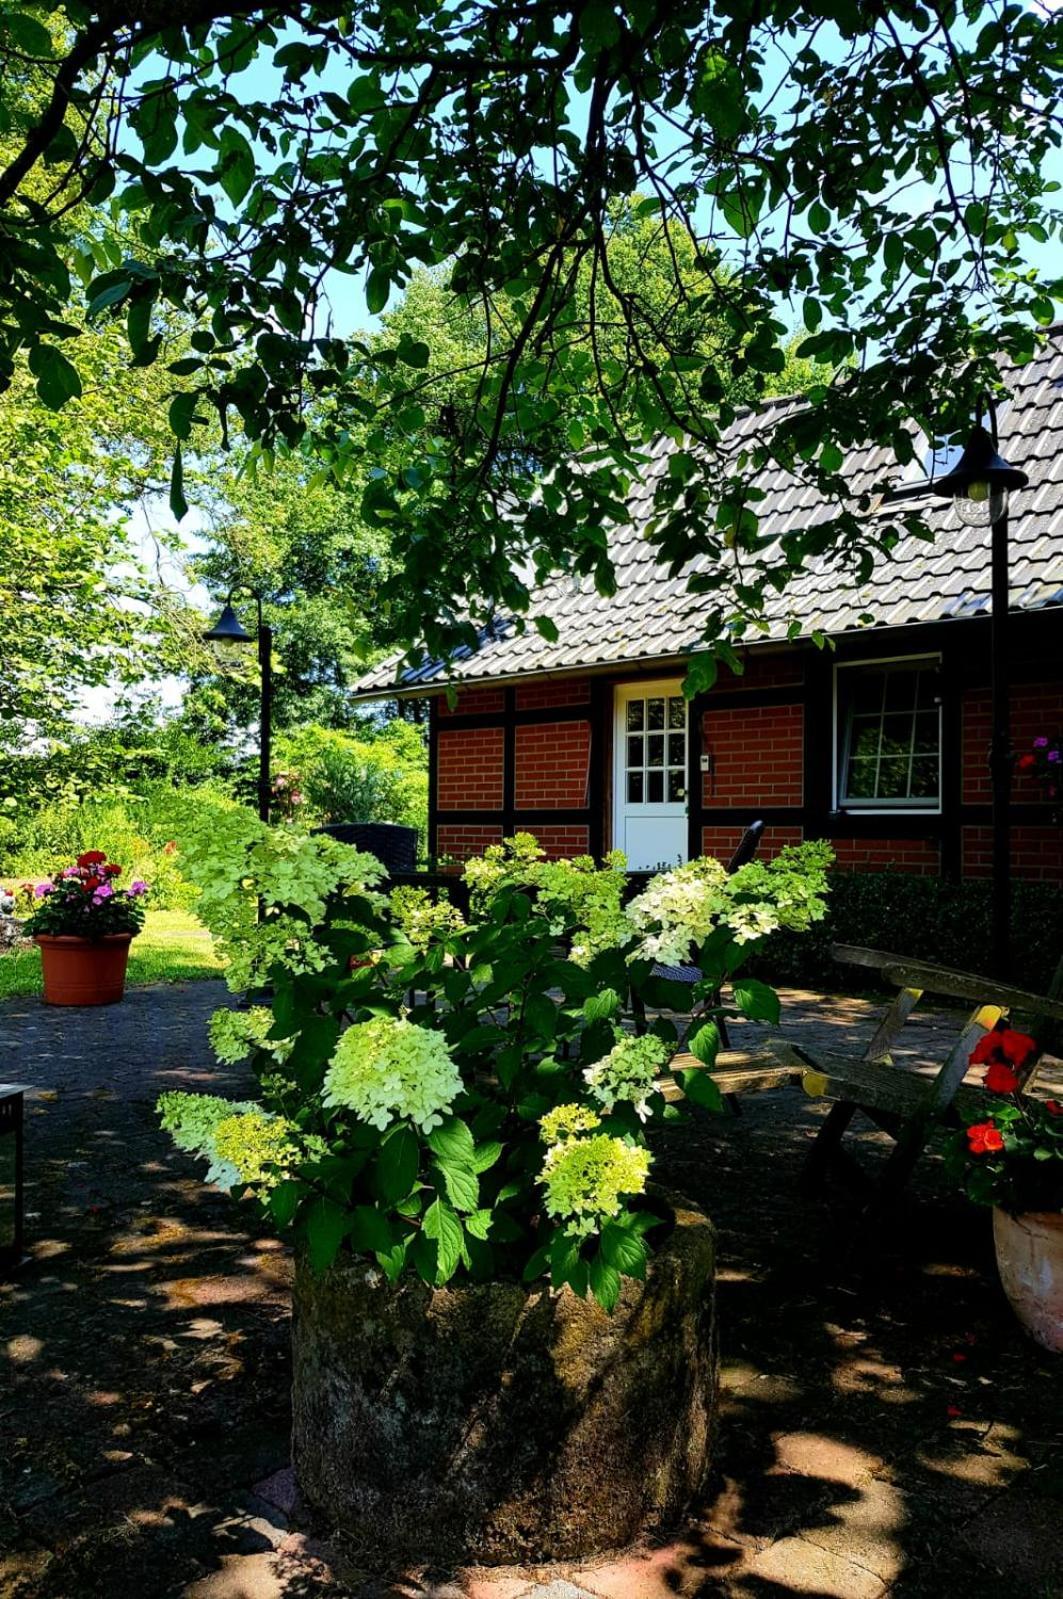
799, 945, 1063, 1199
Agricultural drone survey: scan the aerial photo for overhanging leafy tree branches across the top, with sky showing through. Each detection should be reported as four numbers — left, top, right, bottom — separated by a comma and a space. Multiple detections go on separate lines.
0, 0, 1063, 681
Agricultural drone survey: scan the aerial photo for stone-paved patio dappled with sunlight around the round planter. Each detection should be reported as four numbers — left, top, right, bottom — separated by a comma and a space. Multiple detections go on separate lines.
0, 983, 1063, 1599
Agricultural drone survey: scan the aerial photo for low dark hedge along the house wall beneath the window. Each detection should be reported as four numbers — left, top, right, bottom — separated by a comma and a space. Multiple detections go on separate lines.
750, 871, 1063, 993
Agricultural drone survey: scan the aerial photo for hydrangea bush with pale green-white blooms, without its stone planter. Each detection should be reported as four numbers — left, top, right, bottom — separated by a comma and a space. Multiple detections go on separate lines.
160, 828, 828, 1308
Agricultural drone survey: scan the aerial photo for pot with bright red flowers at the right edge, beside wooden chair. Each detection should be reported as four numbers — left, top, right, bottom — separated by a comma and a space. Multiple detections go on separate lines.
951, 1023, 1063, 1351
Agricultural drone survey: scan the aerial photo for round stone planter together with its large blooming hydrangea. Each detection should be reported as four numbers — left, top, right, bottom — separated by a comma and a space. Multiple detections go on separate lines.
160, 830, 826, 1565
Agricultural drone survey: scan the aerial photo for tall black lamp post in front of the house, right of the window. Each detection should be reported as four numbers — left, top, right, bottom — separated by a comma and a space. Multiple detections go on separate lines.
934, 408, 1029, 977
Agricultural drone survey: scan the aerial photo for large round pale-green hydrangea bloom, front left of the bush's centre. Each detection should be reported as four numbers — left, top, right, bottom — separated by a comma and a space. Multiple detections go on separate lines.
323, 1015, 462, 1132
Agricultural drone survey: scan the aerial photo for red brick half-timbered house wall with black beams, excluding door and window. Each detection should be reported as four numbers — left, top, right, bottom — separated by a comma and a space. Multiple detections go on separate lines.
430, 609, 1063, 883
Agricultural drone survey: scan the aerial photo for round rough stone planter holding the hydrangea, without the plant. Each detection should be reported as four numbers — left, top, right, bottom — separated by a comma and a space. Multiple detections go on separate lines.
293, 1201, 716, 1565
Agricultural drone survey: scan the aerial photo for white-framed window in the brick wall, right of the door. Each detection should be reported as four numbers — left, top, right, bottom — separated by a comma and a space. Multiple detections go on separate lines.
838, 660, 942, 811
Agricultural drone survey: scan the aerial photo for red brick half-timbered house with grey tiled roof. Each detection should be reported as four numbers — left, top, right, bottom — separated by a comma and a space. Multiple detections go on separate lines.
358, 329, 1063, 881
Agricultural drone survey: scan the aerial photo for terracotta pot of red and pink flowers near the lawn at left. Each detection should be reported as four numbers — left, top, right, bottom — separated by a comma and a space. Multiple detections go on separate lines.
26, 849, 147, 1004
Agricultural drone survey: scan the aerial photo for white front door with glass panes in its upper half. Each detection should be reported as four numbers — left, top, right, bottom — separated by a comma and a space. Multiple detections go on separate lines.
612, 680, 687, 871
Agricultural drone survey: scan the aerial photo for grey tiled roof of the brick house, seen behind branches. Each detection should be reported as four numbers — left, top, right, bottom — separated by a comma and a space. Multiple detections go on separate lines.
355, 328, 1063, 697
